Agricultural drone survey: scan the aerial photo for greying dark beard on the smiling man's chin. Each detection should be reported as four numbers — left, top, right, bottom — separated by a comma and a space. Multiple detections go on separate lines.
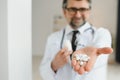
69, 18, 86, 29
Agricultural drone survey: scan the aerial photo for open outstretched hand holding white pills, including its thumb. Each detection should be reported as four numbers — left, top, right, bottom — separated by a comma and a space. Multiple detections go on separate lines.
72, 47, 113, 74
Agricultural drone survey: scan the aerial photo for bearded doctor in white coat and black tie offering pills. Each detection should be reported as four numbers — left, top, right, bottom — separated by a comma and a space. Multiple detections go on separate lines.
40, 0, 112, 80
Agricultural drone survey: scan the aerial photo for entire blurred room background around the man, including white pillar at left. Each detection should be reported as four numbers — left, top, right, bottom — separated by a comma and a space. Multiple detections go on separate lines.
0, 0, 120, 80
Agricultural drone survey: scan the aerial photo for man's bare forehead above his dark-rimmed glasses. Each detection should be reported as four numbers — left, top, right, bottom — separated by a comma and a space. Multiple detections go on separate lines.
67, 0, 89, 8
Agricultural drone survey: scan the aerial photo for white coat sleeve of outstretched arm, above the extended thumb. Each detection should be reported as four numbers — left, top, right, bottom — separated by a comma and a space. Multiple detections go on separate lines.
93, 28, 112, 48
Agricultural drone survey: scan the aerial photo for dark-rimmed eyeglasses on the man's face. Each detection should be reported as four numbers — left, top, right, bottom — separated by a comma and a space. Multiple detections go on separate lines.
66, 7, 90, 14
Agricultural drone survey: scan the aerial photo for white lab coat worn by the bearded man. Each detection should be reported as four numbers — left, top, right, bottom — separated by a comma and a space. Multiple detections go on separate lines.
40, 22, 111, 80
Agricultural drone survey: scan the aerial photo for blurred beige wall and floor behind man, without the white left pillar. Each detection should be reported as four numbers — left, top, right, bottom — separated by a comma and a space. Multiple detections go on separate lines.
32, 0, 120, 80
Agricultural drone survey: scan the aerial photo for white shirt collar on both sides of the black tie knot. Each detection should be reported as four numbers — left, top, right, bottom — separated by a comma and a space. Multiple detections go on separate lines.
65, 22, 91, 35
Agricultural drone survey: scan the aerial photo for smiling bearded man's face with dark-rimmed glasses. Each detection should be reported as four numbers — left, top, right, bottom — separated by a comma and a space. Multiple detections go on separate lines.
64, 0, 90, 29
